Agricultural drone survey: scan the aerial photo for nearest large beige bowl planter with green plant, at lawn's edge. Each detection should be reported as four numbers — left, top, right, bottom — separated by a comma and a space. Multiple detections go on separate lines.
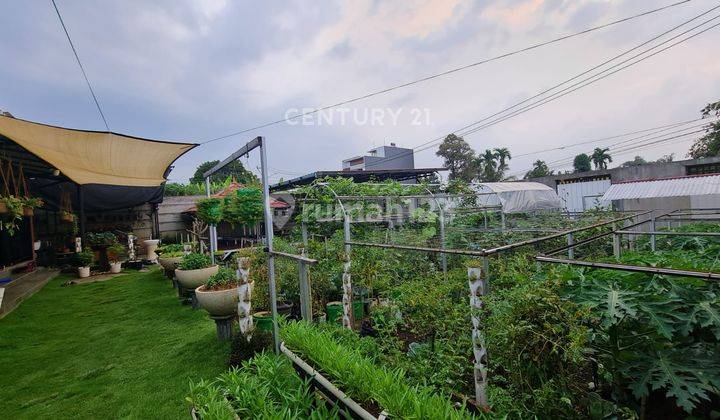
195, 267, 238, 317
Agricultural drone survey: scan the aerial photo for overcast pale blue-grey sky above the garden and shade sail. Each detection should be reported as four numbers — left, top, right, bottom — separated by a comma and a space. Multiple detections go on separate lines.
0, 0, 720, 181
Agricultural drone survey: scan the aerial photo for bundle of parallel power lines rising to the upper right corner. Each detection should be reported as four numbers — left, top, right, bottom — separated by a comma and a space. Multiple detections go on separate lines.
368, 6, 720, 166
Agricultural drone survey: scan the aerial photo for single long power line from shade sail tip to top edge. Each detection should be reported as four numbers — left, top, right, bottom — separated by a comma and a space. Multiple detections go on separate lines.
198, 0, 690, 144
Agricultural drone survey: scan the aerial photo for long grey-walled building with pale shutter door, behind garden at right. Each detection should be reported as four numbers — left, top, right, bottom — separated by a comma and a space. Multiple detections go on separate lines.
526, 157, 720, 212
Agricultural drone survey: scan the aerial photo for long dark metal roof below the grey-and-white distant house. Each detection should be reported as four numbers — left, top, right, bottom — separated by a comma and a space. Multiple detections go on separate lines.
270, 168, 447, 191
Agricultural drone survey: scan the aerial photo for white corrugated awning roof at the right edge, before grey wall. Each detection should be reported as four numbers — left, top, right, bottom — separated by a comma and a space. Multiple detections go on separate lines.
602, 175, 720, 201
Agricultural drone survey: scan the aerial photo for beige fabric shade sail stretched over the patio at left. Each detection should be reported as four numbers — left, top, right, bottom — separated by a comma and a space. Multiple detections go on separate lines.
0, 116, 197, 187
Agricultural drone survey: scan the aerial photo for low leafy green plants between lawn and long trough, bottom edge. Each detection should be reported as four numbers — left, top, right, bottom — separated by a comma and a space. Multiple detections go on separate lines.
187, 353, 339, 420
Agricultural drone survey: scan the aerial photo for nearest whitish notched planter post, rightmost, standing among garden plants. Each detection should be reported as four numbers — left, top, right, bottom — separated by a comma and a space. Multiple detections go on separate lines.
468, 267, 488, 407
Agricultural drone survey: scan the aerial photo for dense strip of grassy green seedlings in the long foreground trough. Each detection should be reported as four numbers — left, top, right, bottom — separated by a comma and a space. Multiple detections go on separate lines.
281, 321, 472, 419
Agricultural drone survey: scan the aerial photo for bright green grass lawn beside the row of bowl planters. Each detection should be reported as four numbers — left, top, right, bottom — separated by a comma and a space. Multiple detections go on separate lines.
0, 269, 228, 419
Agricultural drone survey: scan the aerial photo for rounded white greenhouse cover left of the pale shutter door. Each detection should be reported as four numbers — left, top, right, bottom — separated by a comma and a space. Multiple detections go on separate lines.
475, 182, 562, 213
